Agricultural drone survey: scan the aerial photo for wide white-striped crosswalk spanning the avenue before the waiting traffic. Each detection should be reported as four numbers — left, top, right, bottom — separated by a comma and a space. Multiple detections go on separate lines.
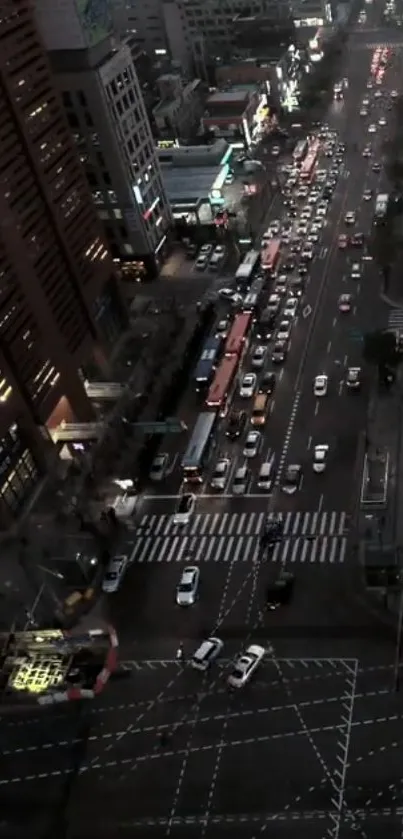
131, 511, 347, 564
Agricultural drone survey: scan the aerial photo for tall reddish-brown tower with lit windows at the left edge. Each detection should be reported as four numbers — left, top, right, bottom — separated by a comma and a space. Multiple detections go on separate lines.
0, 0, 125, 529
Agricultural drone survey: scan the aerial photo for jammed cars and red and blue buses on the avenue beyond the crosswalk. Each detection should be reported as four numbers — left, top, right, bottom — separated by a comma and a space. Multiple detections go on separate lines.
150, 48, 396, 524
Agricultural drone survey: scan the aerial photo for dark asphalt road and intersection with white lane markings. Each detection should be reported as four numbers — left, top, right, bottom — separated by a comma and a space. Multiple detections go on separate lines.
0, 18, 403, 839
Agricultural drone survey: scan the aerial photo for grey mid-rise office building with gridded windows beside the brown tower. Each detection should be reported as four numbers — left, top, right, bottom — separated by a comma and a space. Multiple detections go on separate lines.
35, 0, 172, 277
